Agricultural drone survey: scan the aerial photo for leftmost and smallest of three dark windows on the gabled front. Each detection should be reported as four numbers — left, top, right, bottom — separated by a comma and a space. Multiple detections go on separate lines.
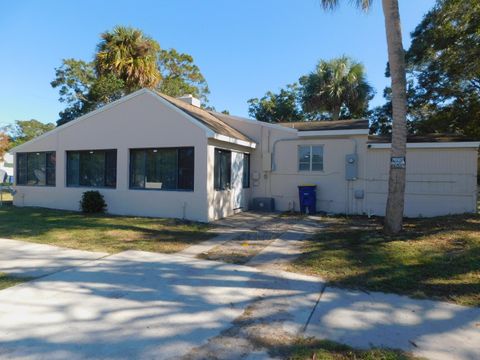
17, 151, 56, 186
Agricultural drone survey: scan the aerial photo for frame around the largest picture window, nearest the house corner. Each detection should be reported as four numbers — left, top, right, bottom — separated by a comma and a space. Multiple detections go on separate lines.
128, 146, 195, 192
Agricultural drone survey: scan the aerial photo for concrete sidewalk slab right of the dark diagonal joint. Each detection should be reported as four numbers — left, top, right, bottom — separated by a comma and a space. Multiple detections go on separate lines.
305, 287, 480, 360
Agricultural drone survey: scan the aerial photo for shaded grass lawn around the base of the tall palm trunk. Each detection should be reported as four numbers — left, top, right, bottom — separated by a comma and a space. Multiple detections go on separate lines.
290, 215, 480, 306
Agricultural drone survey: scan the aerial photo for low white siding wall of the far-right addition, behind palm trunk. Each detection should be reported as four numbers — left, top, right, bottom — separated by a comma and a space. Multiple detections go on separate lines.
366, 148, 478, 217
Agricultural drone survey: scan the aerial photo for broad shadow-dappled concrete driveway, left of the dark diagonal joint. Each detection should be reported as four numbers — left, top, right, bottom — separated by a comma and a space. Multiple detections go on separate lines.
0, 242, 323, 360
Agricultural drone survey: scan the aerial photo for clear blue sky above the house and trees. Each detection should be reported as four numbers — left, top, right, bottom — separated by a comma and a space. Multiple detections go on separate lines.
0, 0, 434, 126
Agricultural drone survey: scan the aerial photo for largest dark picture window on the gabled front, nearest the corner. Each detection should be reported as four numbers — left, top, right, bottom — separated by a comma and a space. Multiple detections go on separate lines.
130, 147, 195, 191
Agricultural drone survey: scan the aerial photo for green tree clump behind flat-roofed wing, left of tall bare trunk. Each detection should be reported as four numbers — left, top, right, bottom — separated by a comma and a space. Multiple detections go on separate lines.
248, 56, 374, 122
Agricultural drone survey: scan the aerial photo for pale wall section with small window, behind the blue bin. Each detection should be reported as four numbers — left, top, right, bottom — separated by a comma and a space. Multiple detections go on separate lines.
216, 119, 367, 214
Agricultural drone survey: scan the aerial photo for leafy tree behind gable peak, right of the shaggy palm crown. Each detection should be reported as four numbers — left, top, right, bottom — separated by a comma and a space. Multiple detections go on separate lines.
157, 49, 210, 103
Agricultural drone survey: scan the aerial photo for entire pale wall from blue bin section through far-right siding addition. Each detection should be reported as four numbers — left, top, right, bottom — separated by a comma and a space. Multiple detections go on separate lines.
219, 115, 478, 217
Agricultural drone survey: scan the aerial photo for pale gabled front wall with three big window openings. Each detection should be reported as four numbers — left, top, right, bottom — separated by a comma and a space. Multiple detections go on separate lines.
14, 93, 208, 221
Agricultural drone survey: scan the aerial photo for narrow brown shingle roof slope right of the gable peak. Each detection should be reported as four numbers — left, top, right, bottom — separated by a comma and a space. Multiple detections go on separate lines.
157, 92, 254, 143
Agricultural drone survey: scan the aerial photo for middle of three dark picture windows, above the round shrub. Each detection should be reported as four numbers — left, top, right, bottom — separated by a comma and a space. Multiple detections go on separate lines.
67, 150, 117, 188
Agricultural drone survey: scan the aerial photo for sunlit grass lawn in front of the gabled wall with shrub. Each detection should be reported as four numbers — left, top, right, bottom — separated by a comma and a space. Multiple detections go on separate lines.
0, 206, 212, 253
